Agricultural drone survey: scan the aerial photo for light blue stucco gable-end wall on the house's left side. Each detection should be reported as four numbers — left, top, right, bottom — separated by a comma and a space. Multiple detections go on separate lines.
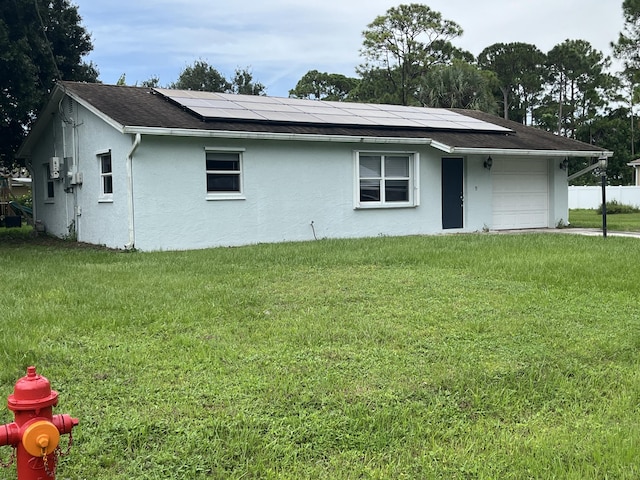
30, 98, 132, 248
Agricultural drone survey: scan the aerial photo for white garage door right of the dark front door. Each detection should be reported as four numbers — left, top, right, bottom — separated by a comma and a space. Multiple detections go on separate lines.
491, 159, 549, 230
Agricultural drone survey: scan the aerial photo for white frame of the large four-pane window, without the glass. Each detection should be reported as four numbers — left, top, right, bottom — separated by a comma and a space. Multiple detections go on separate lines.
354, 150, 420, 209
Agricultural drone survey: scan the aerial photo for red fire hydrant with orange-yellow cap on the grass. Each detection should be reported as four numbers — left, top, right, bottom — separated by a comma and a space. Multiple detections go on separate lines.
0, 367, 78, 480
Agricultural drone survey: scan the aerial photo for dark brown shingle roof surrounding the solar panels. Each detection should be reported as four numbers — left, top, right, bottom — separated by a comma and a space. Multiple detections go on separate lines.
61, 82, 605, 153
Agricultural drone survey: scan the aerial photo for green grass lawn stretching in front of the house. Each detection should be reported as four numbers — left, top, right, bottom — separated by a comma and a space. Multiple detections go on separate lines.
0, 227, 640, 479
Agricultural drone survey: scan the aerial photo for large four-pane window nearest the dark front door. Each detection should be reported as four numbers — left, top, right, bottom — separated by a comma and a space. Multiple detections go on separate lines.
356, 152, 418, 208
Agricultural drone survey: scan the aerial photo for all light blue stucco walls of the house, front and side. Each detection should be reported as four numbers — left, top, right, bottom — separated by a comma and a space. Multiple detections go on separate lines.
31, 99, 568, 250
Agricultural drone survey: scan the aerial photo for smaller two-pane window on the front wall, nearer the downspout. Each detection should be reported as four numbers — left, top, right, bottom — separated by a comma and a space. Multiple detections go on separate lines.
206, 151, 242, 199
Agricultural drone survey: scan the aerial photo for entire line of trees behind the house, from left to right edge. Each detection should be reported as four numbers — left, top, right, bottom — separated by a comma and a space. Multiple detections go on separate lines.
0, 0, 640, 184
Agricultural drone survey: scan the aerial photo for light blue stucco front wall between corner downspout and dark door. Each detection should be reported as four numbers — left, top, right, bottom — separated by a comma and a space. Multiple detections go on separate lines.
133, 137, 460, 250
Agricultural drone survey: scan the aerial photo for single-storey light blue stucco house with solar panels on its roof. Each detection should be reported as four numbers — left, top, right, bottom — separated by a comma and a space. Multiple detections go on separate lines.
19, 82, 611, 250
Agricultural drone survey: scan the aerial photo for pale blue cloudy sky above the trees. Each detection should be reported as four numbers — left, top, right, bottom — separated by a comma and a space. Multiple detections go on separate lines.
72, 0, 623, 97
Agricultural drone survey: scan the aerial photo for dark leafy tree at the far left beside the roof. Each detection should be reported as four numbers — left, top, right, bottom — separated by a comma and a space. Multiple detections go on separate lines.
0, 0, 98, 166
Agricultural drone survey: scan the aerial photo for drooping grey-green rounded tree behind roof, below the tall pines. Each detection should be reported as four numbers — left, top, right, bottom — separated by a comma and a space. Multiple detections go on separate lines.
418, 60, 497, 113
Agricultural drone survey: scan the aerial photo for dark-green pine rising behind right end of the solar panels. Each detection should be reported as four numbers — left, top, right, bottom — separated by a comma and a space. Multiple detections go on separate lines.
477, 42, 545, 125
